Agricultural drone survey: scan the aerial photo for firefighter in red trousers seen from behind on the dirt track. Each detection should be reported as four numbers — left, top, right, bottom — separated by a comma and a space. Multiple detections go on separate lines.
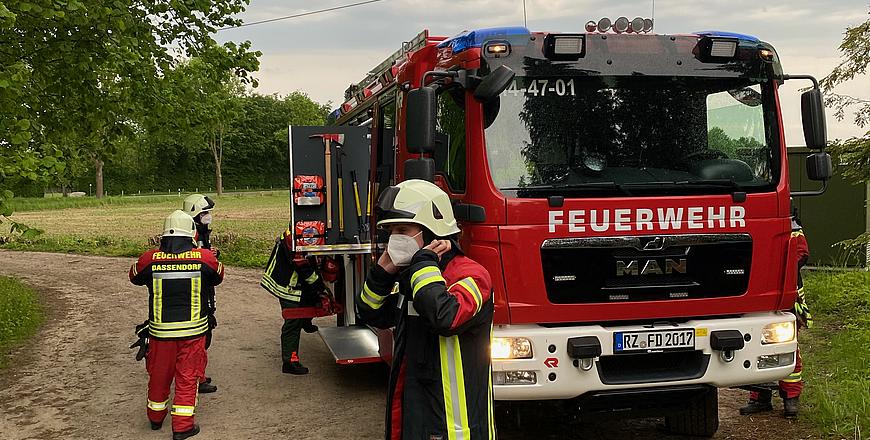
130, 210, 224, 440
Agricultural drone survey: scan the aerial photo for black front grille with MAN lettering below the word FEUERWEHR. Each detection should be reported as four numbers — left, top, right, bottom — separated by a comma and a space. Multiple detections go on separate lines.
541, 234, 752, 304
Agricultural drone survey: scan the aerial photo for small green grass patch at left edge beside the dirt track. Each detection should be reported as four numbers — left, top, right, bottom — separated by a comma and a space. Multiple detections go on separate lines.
0, 277, 43, 368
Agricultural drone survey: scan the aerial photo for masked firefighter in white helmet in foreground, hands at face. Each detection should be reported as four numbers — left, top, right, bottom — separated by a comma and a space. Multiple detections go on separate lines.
355, 180, 495, 440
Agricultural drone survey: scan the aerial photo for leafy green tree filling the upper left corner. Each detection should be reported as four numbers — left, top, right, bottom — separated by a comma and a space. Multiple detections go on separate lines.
0, 0, 259, 199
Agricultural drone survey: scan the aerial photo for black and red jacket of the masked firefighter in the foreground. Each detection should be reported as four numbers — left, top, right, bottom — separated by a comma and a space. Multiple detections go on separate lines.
355, 243, 495, 440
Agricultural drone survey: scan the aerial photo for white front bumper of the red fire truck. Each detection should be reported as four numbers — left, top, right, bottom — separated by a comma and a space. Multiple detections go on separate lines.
492, 312, 797, 400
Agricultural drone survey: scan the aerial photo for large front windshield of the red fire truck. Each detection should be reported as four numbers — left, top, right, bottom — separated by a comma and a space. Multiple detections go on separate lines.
486, 75, 780, 197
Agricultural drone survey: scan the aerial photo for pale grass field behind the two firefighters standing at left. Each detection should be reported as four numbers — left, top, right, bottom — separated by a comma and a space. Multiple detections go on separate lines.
0, 191, 288, 267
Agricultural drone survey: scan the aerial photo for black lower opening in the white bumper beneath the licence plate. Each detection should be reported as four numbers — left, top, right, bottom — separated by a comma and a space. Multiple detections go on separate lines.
596, 350, 710, 385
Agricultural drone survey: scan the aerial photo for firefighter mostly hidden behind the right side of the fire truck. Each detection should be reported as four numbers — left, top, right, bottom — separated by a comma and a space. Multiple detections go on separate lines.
740, 209, 813, 418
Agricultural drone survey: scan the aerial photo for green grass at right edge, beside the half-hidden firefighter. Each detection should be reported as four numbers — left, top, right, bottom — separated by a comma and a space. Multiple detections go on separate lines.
800, 271, 870, 438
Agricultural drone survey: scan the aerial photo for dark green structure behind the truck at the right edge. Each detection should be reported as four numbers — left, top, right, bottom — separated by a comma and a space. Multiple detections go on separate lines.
788, 147, 870, 267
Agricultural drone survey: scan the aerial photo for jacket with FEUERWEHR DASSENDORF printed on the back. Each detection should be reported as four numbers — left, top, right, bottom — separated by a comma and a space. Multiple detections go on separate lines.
130, 237, 224, 339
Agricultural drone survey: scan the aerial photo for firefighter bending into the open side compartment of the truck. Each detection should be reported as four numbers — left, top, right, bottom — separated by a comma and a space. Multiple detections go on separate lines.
260, 229, 326, 375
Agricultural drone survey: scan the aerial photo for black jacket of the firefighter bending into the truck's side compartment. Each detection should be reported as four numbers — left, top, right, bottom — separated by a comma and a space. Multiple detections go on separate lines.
260, 229, 324, 306
